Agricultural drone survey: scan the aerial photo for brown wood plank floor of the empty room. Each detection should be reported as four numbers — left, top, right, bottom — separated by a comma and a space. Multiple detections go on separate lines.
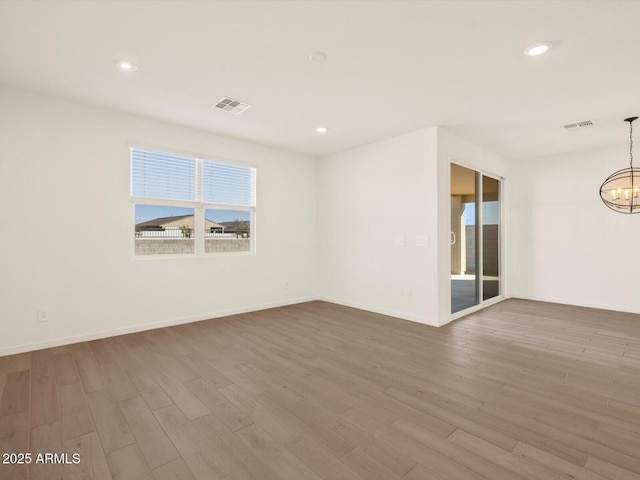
0, 300, 640, 480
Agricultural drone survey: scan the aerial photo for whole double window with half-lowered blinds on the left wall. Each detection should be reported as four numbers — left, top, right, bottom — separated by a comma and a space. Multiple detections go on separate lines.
131, 148, 256, 255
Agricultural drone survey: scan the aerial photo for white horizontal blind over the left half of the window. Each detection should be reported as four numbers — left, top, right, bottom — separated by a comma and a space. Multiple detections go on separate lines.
131, 148, 197, 201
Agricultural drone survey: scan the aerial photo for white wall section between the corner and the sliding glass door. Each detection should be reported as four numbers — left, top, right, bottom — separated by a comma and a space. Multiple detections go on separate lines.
318, 127, 438, 325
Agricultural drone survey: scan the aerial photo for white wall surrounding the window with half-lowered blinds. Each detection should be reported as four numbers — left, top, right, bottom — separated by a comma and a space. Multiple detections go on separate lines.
0, 88, 318, 355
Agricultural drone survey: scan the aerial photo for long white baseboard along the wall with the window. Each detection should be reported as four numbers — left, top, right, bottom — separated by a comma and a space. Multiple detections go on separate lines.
0, 297, 319, 357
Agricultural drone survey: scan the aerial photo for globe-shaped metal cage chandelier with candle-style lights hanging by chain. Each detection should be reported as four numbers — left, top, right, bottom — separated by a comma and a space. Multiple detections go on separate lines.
600, 117, 640, 213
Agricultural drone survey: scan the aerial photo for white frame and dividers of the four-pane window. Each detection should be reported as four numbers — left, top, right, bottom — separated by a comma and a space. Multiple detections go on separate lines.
128, 144, 258, 260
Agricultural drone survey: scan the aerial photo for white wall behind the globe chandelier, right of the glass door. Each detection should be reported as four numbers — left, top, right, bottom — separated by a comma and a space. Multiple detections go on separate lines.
508, 147, 640, 313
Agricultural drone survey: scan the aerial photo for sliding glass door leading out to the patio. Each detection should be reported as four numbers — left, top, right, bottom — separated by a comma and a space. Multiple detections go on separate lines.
451, 163, 501, 313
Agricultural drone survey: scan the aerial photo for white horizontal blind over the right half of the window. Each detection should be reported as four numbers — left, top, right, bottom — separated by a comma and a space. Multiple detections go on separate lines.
202, 160, 256, 207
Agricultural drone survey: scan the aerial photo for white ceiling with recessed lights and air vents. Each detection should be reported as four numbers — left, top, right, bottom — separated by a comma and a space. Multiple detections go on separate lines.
0, 0, 640, 159
